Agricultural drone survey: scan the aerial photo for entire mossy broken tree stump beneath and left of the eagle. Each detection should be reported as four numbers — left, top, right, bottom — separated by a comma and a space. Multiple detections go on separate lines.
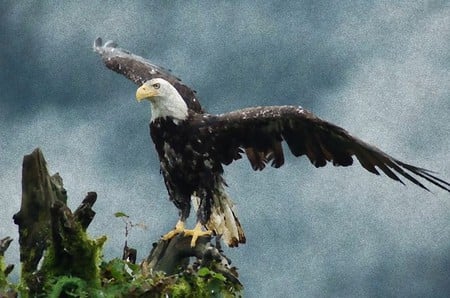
8, 149, 241, 297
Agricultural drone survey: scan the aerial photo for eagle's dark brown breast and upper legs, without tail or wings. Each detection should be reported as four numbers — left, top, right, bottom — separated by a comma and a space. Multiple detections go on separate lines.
150, 118, 223, 224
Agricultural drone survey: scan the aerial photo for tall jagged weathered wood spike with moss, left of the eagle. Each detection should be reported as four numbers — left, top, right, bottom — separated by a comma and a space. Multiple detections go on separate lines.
13, 148, 105, 296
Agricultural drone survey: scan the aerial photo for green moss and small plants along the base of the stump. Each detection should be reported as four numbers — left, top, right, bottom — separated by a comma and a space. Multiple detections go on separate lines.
4, 248, 242, 297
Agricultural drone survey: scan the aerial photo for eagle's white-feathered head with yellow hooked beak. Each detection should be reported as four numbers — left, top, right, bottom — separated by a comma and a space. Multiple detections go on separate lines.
136, 78, 188, 121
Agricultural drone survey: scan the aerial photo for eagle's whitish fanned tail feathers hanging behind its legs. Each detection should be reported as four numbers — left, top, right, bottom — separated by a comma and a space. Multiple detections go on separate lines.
192, 186, 245, 247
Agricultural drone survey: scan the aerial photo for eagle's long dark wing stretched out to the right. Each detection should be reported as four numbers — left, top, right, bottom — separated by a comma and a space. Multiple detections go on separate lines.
201, 106, 450, 192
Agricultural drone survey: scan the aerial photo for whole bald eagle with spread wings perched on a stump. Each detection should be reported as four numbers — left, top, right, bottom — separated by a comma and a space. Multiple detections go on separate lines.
94, 40, 450, 247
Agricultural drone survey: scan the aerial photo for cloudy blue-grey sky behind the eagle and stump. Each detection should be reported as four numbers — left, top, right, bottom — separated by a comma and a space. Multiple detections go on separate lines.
0, 1, 450, 297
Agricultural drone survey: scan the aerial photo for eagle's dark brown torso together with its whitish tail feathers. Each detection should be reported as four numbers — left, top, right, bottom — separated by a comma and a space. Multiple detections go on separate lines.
150, 113, 245, 246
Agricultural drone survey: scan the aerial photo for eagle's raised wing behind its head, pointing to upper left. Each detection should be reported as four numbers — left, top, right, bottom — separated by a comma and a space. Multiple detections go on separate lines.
94, 37, 203, 113
